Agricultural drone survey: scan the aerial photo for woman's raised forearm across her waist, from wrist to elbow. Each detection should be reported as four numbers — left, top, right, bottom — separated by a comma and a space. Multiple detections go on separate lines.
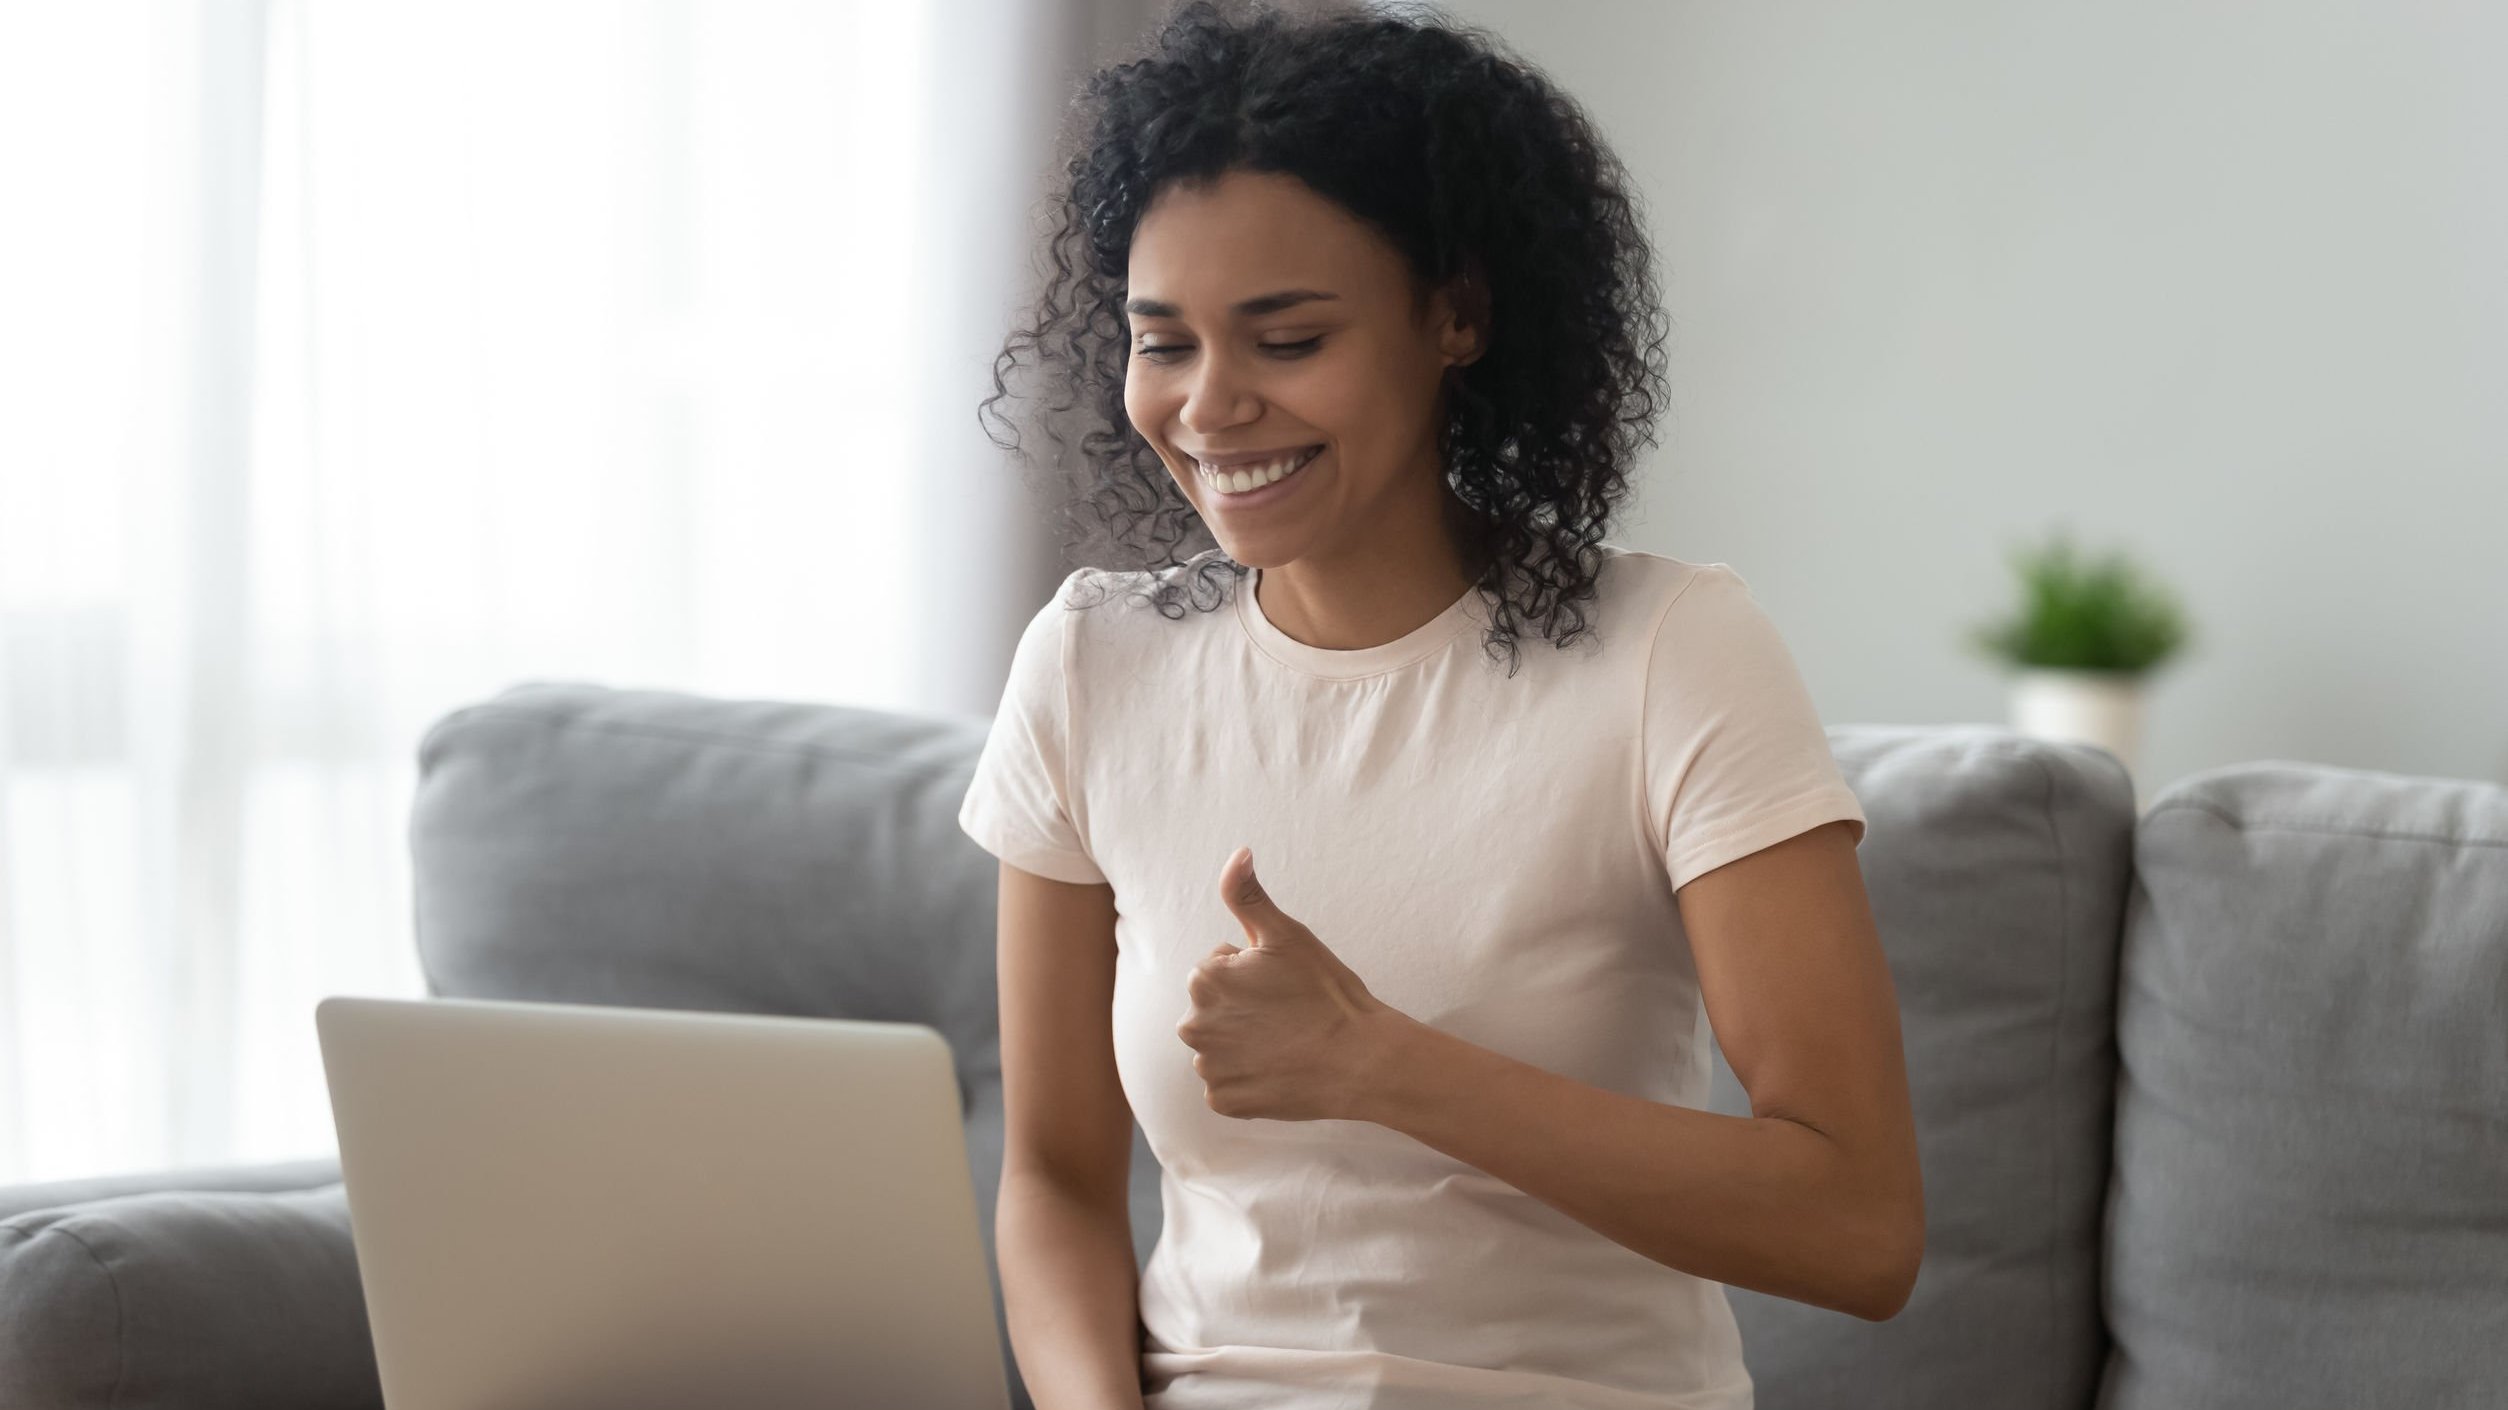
1354, 1011, 1909, 1320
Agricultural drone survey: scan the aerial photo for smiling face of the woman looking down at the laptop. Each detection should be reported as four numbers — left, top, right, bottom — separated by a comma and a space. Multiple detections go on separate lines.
1124, 171, 1477, 567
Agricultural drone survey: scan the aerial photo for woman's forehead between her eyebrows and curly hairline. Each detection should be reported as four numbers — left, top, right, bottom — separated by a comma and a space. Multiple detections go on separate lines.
1129, 171, 1402, 319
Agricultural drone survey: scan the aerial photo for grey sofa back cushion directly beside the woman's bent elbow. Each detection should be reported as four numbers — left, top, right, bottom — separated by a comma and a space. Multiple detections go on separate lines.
1710, 725, 2134, 1410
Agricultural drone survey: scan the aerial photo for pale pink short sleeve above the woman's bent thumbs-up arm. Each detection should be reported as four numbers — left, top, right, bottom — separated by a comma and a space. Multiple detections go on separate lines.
1643, 562, 1863, 891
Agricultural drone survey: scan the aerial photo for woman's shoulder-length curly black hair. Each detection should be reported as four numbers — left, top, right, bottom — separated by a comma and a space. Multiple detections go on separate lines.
978, 0, 1668, 677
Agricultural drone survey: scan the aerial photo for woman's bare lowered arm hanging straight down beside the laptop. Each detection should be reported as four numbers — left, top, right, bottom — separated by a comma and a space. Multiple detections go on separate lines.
993, 863, 1141, 1410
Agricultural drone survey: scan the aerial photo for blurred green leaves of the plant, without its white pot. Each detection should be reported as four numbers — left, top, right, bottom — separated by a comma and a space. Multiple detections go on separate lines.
1969, 529, 2189, 675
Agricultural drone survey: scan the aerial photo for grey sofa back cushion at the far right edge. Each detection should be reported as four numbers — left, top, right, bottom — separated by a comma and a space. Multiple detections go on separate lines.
2102, 763, 2508, 1410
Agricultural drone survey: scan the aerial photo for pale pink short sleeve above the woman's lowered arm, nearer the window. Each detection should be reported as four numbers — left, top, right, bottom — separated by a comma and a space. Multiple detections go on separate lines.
958, 570, 1106, 883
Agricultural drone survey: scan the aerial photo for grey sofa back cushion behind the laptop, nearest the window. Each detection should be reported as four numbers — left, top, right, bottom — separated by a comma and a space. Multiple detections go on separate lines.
411, 682, 1001, 1086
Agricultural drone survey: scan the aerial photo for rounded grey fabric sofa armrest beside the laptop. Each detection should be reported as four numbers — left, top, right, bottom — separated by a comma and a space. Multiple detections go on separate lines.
0, 1184, 384, 1410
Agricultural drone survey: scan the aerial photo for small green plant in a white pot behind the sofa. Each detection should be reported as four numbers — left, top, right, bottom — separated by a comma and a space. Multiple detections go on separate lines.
1969, 527, 2189, 798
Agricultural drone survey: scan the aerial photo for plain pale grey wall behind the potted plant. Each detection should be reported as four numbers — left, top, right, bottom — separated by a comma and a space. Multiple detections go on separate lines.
1445, 0, 2508, 793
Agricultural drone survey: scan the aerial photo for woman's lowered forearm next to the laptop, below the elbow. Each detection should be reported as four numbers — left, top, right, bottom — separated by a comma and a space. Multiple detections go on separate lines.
993, 1174, 1141, 1410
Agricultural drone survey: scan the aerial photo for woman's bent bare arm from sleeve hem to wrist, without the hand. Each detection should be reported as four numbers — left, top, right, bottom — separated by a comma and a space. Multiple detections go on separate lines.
1359, 823, 1924, 1322
